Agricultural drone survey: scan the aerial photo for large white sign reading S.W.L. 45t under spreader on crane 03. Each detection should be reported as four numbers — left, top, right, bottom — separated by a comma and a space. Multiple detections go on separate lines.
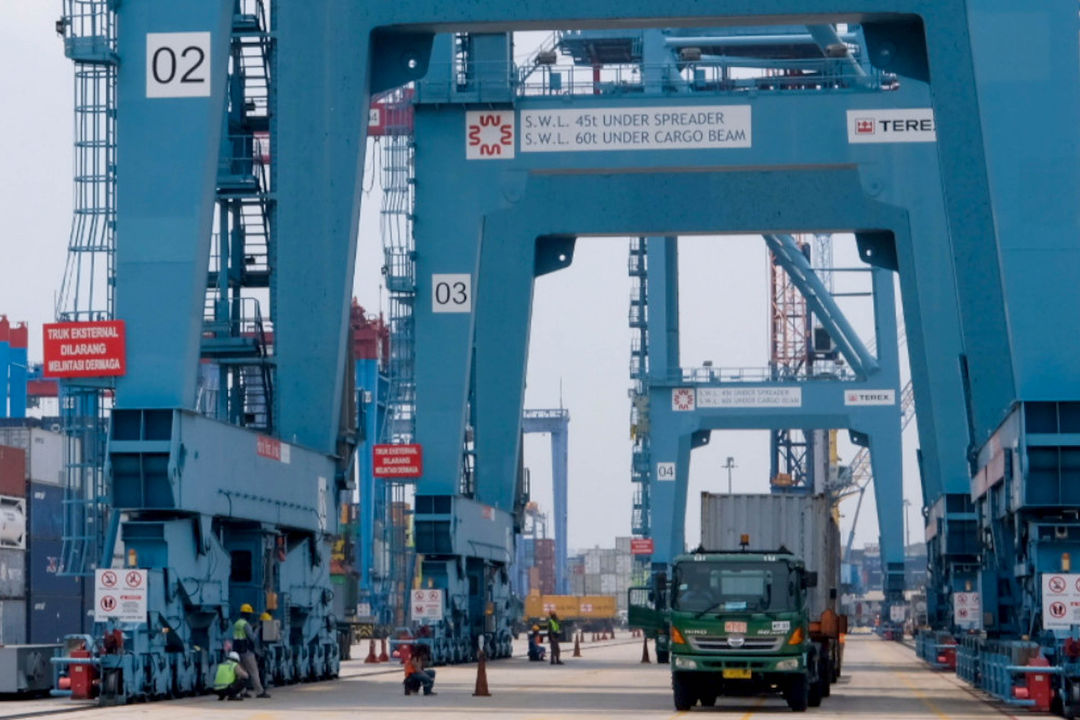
518, 105, 753, 152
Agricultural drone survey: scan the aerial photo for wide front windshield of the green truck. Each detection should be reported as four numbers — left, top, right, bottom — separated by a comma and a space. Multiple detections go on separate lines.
672, 560, 799, 613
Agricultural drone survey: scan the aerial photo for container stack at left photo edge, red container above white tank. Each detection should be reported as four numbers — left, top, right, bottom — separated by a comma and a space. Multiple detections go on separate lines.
0, 445, 27, 646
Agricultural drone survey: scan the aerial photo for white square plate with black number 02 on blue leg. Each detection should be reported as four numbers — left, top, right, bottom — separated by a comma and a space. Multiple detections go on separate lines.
146, 32, 211, 97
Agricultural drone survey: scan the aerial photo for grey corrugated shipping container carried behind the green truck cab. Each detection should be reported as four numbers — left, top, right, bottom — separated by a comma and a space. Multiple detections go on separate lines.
701, 492, 840, 617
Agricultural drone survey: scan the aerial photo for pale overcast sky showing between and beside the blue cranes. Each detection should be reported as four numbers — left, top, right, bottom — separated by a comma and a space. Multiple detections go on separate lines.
0, 5, 921, 547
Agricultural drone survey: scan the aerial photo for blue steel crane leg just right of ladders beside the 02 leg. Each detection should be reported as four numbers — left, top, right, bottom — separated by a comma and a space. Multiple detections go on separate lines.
274, 0, 380, 453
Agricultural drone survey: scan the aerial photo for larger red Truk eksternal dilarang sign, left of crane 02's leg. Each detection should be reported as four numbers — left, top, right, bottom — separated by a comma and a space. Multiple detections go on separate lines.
42, 320, 126, 378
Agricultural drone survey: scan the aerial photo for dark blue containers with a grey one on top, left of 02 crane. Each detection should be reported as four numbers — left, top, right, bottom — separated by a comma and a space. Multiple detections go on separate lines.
0, 419, 88, 644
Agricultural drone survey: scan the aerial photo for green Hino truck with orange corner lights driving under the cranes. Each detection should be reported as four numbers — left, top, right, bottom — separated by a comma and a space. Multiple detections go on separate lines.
629, 499, 847, 712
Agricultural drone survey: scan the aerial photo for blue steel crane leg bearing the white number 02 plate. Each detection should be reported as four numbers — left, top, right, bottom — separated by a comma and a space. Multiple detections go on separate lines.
116, 0, 233, 408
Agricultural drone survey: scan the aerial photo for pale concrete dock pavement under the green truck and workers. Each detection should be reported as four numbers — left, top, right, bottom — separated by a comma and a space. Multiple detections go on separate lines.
0, 633, 1044, 720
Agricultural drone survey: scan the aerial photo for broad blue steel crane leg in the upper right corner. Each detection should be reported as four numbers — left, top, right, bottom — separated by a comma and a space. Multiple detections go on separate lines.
967, 0, 1080, 410
